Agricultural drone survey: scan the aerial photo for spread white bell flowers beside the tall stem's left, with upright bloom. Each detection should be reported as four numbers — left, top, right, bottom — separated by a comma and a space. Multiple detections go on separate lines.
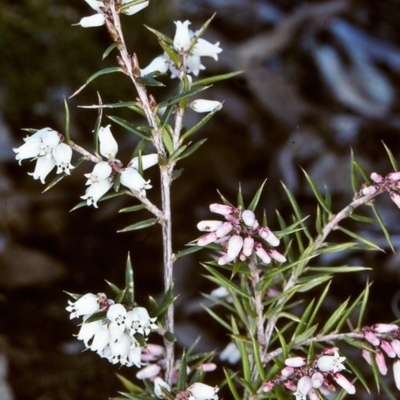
81, 125, 158, 208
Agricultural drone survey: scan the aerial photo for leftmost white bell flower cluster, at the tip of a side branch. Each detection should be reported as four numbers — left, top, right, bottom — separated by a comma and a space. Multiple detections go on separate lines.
13, 128, 74, 184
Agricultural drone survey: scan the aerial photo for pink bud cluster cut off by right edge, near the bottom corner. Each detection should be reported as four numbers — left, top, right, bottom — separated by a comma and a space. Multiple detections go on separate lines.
361, 324, 400, 390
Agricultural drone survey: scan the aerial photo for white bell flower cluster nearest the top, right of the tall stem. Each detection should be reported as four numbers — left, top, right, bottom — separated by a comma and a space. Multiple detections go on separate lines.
141, 21, 222, 79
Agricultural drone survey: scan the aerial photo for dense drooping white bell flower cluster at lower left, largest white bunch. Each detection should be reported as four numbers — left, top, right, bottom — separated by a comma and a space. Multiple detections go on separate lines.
66, 293, 157, 368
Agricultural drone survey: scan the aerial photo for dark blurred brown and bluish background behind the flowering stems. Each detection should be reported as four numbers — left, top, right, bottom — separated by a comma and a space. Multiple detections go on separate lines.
0, 0, 400, 400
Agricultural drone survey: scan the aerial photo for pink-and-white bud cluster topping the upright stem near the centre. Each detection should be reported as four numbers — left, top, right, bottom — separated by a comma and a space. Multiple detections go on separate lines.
197, 204, 286, 265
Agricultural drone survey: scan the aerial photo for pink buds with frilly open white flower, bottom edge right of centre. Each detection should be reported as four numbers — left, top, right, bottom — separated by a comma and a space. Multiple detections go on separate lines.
263, 347, 356, 400
